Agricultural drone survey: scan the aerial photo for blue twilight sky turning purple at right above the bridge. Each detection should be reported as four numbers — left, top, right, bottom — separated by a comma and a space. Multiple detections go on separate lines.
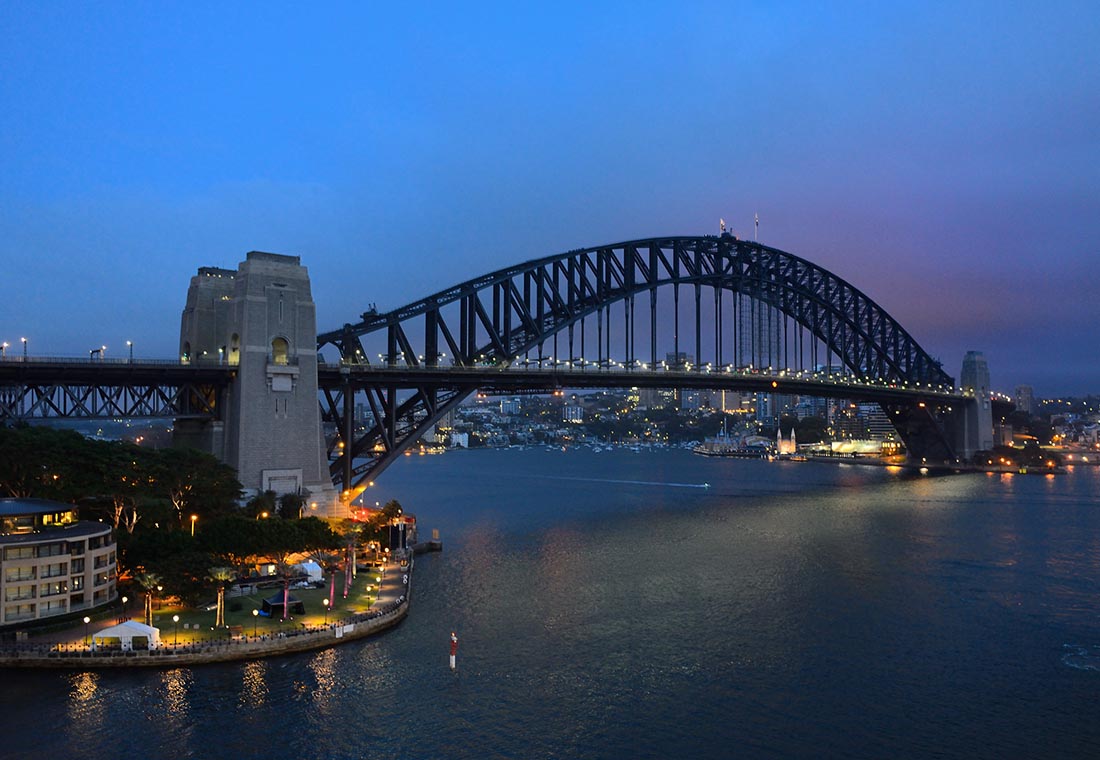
0, 5, 1100, 396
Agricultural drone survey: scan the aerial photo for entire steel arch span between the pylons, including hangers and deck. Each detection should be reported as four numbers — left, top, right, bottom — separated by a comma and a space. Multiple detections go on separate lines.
318, 234, 961, 488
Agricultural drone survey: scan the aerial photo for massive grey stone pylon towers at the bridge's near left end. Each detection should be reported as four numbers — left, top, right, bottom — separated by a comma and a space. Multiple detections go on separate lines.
176, 251, 342, 517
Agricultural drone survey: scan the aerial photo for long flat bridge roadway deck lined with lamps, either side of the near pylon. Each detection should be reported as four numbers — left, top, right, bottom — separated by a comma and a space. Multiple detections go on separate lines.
0, 356, 965, 420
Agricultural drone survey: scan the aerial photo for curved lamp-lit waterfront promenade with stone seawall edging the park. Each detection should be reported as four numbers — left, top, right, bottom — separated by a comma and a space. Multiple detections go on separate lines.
0, 558, 414, 669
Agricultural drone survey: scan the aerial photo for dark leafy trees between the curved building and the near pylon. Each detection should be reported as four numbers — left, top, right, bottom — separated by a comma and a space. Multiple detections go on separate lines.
0, 426, 356, 602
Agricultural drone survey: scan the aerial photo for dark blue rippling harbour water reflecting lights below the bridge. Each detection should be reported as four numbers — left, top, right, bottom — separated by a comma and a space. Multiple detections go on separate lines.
0, 450, 1100, 759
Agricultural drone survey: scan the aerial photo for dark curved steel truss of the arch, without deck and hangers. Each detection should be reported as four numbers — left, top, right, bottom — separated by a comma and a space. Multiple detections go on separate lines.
318, 235, 954, 487
